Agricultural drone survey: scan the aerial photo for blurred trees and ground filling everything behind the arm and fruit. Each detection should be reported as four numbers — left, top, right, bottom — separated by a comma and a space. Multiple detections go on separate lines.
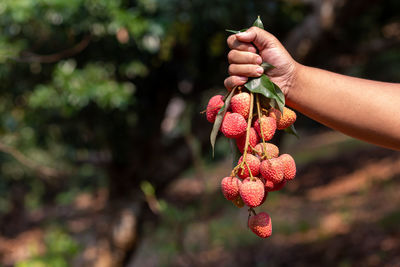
0, 0, 400, 267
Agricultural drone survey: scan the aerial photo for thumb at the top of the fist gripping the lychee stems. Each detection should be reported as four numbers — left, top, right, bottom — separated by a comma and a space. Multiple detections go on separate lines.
236, 27, 279, 51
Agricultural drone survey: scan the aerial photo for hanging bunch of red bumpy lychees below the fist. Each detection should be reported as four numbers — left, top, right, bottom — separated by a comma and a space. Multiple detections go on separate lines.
206, 87, 296, 238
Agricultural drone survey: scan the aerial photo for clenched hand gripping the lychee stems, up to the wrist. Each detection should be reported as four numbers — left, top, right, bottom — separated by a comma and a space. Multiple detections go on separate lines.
224, 27, 299, 95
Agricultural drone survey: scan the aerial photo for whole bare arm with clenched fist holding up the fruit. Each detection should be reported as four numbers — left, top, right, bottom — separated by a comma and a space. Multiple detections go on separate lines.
224, 27, 400, 150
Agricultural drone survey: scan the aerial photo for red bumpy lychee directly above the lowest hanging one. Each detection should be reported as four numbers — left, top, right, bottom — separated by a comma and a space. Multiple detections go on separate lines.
239, 177, 265, 207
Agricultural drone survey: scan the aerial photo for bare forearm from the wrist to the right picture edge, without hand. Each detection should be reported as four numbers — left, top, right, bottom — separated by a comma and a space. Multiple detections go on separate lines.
287, 65, 400, 150
